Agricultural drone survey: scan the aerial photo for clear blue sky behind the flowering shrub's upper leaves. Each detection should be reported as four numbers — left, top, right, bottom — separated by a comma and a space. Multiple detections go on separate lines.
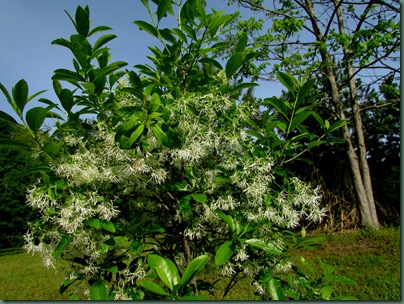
0, 0, 281, 120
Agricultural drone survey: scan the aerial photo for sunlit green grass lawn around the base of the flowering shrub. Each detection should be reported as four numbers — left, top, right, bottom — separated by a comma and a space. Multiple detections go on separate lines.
0, 228, 400, 300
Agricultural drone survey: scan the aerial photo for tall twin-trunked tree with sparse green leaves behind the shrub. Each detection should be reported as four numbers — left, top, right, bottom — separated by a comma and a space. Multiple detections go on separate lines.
228, 0, 400, 229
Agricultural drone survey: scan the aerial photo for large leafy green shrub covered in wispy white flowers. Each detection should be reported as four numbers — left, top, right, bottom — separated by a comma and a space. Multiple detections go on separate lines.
0, 0, 360, 300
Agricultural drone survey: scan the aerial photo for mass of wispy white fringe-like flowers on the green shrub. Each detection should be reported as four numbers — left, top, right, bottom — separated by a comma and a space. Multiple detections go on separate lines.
21, 94, 325, 299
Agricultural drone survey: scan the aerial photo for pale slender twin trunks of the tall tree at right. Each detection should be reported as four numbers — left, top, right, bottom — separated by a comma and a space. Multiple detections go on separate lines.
302, 0, 379, 229
